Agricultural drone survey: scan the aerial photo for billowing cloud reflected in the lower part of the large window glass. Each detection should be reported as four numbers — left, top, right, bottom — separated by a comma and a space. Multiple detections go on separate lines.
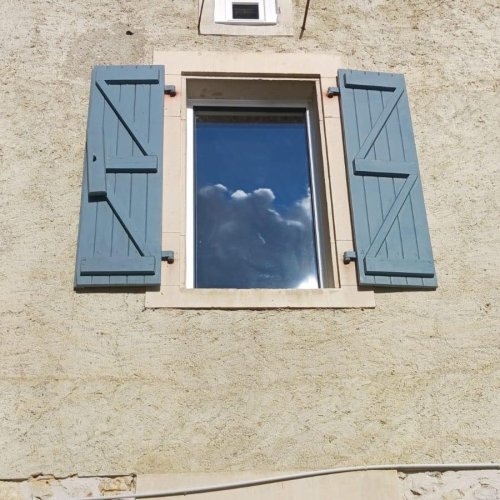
196, 184, 318, 288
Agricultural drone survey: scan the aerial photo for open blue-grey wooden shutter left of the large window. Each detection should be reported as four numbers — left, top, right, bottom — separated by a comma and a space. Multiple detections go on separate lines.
75, 66, 164, 288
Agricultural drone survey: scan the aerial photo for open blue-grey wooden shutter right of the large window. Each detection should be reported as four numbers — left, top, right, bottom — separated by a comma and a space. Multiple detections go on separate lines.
338, 70, 437, 288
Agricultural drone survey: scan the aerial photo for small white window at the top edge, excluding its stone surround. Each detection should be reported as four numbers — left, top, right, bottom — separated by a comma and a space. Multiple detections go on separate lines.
214, 0, 278, 25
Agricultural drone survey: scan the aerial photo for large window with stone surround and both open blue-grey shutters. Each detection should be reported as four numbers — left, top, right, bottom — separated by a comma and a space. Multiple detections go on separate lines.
75, 52, 436, 308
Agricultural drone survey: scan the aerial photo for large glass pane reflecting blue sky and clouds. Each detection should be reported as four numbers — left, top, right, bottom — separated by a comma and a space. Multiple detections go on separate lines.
194, 108, 318, 288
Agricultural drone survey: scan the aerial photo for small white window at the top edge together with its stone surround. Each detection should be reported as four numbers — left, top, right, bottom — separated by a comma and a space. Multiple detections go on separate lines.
199, 0, 294, 36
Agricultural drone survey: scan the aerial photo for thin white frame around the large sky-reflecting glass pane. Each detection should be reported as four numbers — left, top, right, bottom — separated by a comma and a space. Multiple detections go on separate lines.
185, 99, 331, 288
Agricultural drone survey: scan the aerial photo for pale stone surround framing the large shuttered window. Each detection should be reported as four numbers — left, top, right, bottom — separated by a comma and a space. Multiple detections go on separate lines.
146, 51, 375, 309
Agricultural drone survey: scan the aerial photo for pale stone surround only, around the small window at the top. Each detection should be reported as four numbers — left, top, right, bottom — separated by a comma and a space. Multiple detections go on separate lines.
198, 0, 294, 36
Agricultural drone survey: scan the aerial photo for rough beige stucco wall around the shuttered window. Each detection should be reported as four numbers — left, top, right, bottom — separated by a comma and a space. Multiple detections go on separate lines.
0, 0, 500, 478
